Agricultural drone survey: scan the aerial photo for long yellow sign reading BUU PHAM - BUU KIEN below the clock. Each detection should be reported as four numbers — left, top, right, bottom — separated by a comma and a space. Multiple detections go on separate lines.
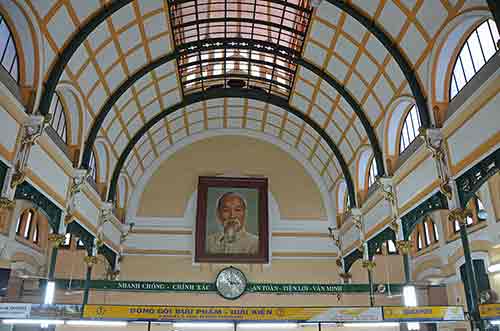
83, 305, 382, 321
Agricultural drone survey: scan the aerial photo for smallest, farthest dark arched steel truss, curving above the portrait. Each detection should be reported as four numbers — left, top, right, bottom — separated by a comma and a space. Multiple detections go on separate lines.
108, 88, 356, 207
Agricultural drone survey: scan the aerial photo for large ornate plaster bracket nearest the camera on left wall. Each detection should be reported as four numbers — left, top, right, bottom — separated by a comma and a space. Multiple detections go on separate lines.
10, 114, 52, 189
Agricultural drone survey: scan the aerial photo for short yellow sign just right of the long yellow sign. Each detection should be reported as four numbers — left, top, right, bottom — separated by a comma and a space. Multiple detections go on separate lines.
384, 306, 465, 321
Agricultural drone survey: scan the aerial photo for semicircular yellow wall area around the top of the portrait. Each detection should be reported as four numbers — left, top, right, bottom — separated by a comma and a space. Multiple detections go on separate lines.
137, 136, 326, 220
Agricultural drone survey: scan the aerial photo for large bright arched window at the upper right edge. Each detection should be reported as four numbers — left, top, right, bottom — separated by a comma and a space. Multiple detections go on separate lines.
450, 19, 499, 100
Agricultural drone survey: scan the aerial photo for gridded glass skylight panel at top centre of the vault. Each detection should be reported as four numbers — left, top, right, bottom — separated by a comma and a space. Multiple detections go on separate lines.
169, 0, 311, 97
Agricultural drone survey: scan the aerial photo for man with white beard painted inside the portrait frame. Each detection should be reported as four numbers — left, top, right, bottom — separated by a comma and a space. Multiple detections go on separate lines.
207, 192, 259, 255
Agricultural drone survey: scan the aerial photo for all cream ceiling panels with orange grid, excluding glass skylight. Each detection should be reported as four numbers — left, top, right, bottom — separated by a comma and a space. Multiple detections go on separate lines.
24, 0, 488, 200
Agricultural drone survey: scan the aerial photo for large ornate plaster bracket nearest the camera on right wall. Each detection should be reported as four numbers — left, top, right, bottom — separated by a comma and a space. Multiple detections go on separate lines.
420, 127, 453, 200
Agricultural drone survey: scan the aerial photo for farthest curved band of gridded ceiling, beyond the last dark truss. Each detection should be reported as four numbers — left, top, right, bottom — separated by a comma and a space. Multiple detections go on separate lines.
124, 98, 340, 189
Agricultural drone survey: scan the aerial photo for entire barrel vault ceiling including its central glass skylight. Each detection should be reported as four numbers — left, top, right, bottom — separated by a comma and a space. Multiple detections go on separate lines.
28, 0, 487, 208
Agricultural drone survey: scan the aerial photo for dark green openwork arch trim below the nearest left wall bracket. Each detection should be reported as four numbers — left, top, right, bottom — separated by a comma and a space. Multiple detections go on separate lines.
14, 181, 62, 233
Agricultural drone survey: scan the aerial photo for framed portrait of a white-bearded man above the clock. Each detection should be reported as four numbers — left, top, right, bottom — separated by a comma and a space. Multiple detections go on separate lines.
195, 177, 269, 263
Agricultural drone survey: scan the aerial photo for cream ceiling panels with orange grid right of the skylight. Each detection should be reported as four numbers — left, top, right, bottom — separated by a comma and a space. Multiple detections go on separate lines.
291, 0, 452, 188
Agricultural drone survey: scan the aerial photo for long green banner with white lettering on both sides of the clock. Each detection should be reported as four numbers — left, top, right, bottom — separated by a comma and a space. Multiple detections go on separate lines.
48, 279, 403, 294
